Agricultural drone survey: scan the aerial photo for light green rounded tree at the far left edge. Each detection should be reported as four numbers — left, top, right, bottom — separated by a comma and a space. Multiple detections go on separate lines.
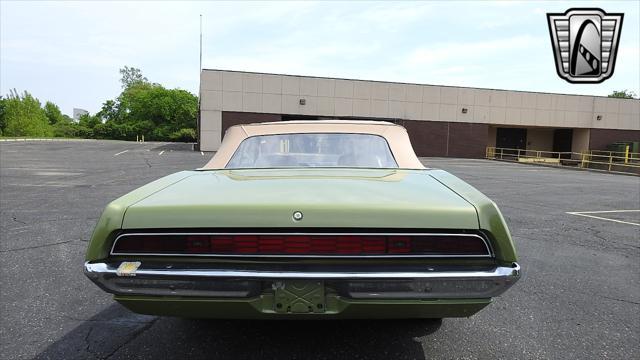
2, 90, 53, 137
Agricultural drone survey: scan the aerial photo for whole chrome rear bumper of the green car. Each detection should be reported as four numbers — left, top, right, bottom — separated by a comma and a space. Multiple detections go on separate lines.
84, 262, 520, 299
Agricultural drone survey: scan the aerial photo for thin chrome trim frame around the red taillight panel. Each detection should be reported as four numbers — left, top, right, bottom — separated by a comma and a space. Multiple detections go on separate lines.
109, 232, 494, 259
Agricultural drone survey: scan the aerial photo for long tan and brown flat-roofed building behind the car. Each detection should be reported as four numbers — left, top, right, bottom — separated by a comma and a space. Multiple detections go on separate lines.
199, 70, 640, 157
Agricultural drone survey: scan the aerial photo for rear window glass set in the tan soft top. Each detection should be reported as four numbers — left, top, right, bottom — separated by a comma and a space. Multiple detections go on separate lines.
225, 133, 398, 169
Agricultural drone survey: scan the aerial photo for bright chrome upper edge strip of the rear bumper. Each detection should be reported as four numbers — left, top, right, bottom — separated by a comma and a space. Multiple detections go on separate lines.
84, 262, 520, 281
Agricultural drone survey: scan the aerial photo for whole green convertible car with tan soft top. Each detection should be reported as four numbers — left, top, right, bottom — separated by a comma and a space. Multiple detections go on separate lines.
84, 120, 520, 319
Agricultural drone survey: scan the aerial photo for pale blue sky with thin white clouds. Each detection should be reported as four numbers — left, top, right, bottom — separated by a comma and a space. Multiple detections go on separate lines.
0, 0, 640, 114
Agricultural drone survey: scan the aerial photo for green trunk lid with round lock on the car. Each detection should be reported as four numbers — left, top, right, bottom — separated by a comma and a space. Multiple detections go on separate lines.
123, 169, 478, 229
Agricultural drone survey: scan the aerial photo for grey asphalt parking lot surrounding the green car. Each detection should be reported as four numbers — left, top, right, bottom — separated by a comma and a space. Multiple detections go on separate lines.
0, 141, 640, 359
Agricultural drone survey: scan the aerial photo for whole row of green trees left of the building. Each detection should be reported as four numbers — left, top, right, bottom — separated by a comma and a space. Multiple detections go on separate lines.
0, 66, 198, 141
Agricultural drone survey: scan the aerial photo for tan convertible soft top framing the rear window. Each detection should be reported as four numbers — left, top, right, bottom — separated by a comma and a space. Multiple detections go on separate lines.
203, 120, 424, 169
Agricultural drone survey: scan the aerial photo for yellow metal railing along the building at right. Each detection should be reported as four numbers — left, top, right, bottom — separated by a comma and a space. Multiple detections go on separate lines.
485, 146, 640, 175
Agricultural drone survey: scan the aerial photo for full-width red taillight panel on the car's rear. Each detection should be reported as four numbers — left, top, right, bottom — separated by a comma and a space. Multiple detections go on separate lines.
112, 234, 490, 256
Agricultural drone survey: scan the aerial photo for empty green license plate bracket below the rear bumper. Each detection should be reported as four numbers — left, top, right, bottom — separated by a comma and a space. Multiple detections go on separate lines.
273, 280, 325, 314
